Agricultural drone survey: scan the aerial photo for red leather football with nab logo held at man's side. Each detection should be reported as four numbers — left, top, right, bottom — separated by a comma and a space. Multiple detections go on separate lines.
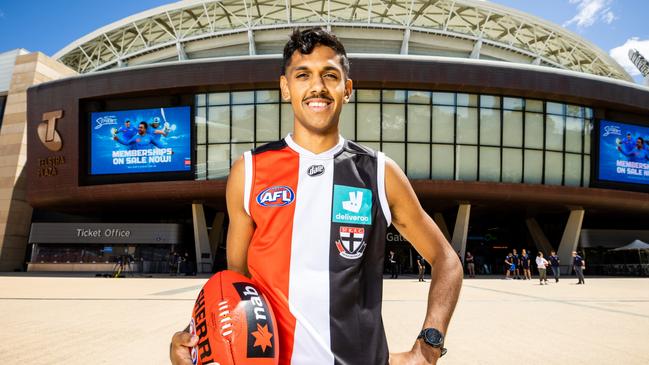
189, 270, 279, 365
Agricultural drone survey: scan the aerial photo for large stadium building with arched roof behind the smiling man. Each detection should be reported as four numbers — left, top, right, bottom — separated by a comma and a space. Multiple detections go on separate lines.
0, 0, 649, 273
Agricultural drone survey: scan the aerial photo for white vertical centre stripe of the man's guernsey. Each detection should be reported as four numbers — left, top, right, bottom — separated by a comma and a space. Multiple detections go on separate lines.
288, 155, 334, 365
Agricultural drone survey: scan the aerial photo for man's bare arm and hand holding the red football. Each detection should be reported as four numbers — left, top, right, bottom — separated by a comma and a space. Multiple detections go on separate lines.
169, 159, 254, 365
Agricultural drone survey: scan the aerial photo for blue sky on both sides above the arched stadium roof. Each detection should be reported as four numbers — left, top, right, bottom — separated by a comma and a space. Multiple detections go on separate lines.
0, 0, 649, 82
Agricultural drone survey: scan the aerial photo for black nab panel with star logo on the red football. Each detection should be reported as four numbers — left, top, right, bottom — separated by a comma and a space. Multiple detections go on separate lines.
233, 283, 276, 358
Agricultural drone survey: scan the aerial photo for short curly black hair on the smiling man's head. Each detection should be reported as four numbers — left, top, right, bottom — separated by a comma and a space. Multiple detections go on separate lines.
282, 27, 349, 78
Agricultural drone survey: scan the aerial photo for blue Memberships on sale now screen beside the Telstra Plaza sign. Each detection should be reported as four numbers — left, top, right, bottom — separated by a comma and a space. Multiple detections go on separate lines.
90, 106, 192, 175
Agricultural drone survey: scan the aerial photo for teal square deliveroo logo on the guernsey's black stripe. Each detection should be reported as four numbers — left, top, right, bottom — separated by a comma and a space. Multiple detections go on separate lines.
331, 185, 372, 225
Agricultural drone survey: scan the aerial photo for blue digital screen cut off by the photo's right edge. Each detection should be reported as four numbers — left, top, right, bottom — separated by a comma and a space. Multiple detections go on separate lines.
599, 120, 649, 185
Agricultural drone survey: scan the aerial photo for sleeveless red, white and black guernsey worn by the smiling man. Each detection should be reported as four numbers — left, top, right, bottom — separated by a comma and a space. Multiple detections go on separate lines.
244, 135, 391, 365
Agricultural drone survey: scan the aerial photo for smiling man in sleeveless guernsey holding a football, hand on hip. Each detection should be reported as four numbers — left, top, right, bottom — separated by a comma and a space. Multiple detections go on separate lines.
171, 28, 462, 365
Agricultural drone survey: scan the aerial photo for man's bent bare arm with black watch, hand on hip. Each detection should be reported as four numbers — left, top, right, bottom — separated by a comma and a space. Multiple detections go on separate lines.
385, 158, 463, 365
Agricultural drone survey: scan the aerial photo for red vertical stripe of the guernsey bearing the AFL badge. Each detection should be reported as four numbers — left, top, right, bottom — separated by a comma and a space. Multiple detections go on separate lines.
248, 146, 299, 365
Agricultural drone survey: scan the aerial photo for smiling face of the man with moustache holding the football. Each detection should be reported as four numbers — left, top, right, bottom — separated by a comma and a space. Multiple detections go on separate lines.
280, 45, 352, 134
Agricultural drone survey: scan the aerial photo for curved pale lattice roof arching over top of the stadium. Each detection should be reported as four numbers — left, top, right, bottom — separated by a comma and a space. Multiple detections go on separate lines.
54, 0, 632, 81
